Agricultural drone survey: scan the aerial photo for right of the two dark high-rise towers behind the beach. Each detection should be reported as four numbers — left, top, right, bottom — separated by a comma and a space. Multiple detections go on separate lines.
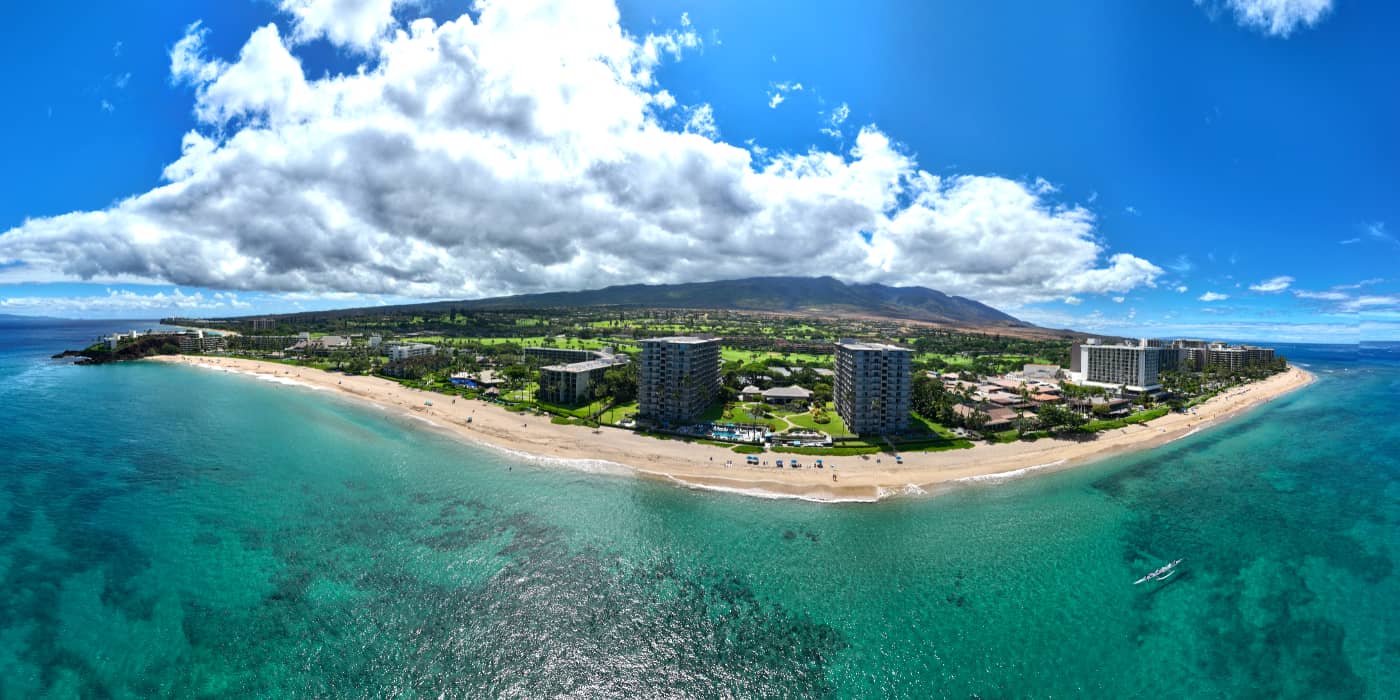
833, 340, 914, 435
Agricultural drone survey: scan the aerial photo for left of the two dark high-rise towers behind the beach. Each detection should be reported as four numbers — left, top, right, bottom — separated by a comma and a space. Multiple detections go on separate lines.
637, 336, 720, 424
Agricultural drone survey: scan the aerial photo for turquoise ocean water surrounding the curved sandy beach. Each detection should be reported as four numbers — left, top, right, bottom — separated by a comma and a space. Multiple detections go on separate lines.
0, 322, 1400, 699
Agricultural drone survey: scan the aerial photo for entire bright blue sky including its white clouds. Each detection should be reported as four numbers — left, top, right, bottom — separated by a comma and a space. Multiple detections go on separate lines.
0, 0, 1400, 340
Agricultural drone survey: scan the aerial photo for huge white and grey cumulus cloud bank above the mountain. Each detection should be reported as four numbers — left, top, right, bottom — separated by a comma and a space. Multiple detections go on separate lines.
0, 0, 1162, 307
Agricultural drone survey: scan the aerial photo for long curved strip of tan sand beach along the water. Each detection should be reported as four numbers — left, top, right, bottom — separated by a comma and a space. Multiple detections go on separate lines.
148, 356, 1316, 503
